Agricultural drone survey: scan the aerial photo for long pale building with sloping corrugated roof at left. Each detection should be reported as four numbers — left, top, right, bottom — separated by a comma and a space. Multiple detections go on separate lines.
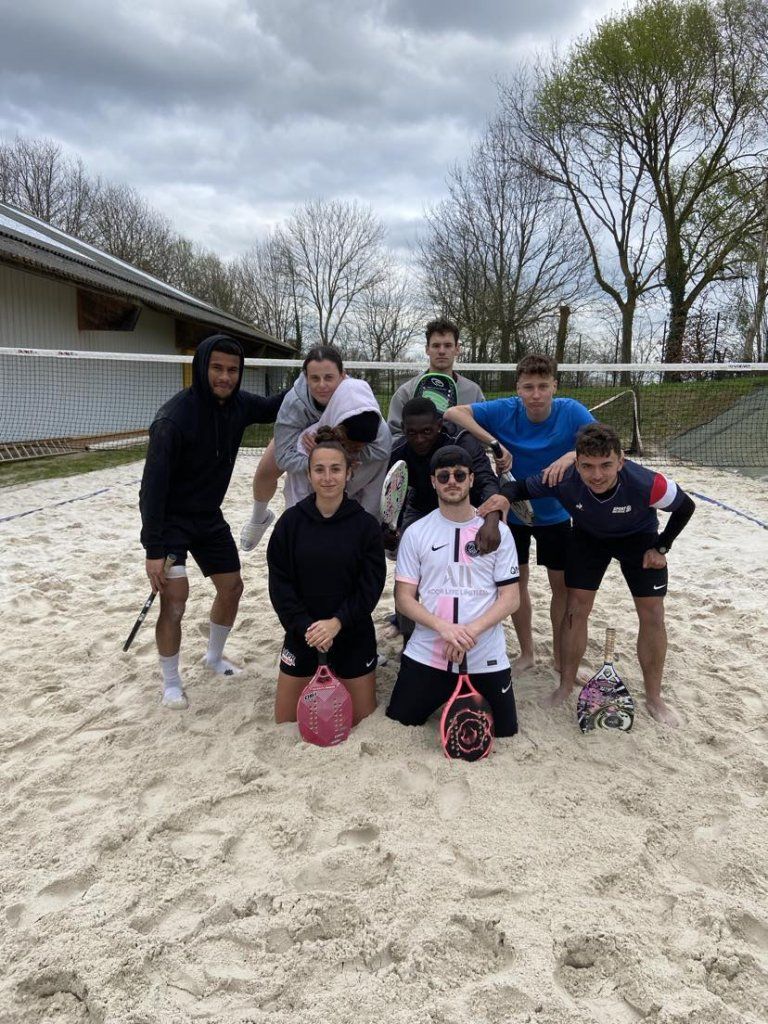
0, 203, 297, 462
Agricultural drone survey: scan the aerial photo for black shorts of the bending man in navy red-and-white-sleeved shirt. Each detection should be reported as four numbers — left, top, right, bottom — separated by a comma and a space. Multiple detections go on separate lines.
565, 526, 668, 597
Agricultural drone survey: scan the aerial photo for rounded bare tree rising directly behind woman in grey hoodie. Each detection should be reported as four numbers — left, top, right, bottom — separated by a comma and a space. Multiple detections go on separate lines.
278, 200, 384, 345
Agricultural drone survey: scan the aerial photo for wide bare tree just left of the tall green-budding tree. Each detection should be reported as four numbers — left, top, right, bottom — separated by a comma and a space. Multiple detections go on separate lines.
422, 118, 584, 362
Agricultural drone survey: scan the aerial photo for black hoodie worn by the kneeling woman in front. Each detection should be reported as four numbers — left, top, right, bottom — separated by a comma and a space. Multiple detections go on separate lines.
266, 495, 387, 636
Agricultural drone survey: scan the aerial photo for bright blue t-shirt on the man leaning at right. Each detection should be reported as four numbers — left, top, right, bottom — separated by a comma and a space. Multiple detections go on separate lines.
472, 397, 595, 526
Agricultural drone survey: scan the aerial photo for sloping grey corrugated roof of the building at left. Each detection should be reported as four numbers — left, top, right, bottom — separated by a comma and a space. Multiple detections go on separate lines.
0, 203, 295, 355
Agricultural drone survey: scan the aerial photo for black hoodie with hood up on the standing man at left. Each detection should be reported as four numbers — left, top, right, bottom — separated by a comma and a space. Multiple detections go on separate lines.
139, 334, 285, 558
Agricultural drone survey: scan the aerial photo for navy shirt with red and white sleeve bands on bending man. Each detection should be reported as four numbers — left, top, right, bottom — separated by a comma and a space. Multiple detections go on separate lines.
525, 459, 686, 538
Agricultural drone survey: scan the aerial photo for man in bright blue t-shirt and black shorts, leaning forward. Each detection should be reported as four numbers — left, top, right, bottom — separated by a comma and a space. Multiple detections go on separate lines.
443, 354, 594, 675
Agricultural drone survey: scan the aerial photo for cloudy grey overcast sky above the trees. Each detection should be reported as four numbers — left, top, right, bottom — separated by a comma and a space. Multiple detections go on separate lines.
0, 0, 618, 256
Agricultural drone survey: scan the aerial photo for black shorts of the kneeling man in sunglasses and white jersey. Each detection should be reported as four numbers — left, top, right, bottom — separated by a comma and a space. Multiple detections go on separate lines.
387, 654, 517, 736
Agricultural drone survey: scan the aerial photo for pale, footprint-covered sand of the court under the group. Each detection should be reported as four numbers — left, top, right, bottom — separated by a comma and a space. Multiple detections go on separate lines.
0, 457, 768, 1024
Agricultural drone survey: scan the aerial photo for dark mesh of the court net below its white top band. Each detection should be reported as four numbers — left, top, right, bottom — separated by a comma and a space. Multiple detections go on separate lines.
0, 351, 768, 467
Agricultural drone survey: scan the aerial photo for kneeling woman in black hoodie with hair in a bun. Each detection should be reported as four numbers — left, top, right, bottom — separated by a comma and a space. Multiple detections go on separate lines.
266, 427, 386, 725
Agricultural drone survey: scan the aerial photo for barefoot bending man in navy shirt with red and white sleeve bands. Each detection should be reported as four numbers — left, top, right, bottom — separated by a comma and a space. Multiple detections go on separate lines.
477, 423, 695, 726
